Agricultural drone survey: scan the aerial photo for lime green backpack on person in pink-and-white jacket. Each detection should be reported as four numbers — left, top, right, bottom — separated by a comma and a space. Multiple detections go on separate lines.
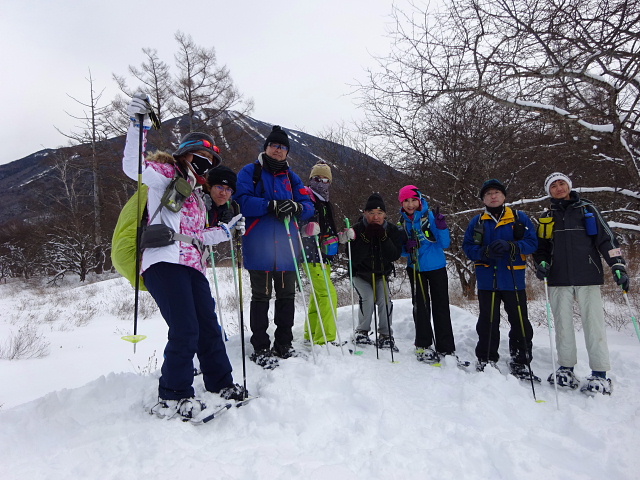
111, 184, 149, 291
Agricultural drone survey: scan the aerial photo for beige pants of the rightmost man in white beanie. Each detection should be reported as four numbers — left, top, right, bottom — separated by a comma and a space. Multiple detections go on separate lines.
549, 285, 611, 372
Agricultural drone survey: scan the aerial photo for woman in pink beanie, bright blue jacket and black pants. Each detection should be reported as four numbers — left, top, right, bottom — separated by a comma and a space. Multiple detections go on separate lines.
398, 185, 456, 363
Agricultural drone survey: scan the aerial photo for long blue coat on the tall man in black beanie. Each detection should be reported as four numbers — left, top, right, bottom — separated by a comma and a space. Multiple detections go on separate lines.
233, 154, 314, 272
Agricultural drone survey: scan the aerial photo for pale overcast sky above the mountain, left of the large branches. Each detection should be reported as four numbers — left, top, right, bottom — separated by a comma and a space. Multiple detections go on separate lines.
0, 0, 404, 163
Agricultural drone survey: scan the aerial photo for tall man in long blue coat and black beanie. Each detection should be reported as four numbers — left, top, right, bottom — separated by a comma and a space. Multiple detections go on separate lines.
234, 125, 314, 368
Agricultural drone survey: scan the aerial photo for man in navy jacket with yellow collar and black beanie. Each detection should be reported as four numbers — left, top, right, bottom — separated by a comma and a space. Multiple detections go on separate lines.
462, 179, 540, 381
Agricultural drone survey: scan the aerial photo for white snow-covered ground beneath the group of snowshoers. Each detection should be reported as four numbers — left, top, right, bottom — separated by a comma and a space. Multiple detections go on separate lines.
0, 270, 640, 480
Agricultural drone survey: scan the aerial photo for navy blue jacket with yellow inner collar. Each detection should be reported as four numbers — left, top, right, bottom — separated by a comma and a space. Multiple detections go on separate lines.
462, 207, 538, 290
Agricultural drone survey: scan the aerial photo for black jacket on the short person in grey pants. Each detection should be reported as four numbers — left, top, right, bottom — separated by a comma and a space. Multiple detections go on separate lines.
351, 217, 405, 283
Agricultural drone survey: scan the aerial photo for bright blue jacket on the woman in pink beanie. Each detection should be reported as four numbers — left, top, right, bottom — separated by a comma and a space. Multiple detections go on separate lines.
400, 198, 451, 272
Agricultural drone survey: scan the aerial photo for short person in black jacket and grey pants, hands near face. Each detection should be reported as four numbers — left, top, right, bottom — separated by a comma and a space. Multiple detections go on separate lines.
351, 193, 404, 352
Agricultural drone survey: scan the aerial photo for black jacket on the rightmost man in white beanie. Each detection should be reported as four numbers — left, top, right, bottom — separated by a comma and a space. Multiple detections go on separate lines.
533, 191, 624, 287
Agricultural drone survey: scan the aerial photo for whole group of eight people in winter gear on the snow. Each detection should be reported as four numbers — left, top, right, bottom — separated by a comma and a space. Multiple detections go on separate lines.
123, 95, 629, 418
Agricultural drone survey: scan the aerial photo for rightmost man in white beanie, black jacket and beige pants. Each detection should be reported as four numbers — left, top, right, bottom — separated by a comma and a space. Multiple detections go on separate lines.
533, 172, 629, 395
